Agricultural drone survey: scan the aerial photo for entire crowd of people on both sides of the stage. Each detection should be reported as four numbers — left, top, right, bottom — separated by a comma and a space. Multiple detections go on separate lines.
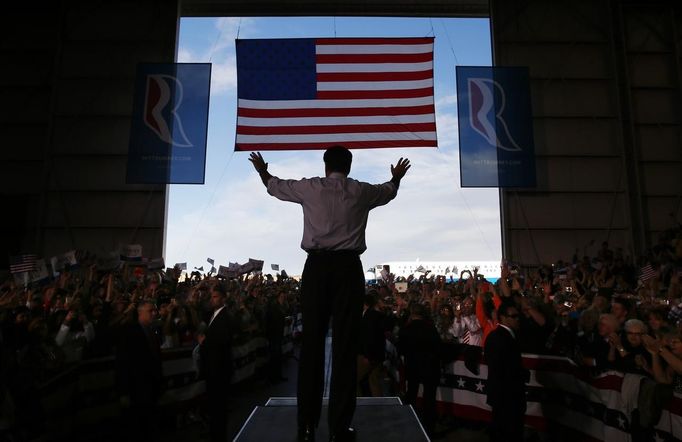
0, 228, 682, 440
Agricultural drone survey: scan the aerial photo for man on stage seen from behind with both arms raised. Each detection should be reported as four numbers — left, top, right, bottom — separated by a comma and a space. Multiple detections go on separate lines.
249, 146, 410, 441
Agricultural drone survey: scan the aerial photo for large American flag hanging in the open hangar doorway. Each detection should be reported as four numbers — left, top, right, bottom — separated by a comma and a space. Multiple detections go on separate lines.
235, 38, 437, 151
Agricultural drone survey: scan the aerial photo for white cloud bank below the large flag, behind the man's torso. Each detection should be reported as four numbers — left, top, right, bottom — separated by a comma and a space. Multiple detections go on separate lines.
167, 149, 500, 274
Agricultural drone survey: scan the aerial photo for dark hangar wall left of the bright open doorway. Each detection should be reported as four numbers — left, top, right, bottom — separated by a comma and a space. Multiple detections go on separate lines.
0, 1, 178, 268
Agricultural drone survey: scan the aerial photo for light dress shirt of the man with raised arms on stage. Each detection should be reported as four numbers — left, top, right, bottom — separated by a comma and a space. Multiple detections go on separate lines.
268, 172, 398, 254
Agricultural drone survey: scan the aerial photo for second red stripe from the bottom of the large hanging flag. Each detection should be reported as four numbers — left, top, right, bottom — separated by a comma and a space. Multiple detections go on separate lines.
237, 123, 436, 135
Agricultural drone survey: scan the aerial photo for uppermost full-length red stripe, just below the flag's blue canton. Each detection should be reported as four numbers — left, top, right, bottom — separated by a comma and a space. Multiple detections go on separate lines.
237, 104, 433, 118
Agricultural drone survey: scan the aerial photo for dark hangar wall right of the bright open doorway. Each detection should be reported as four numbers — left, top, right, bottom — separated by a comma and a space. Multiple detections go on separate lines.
491, 0, 682, 264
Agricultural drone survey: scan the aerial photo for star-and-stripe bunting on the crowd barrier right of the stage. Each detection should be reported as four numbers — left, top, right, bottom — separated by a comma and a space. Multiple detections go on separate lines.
410, 354, 682, 442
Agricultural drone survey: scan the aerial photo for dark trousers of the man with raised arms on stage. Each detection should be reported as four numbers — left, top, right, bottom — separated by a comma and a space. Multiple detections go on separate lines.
298, 252, 365, 433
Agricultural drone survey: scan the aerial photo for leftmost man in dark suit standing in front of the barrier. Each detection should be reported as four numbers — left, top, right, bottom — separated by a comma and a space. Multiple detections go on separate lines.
116, 302, 162, 441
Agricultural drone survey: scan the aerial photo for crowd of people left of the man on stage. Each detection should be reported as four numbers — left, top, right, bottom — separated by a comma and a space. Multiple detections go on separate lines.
0, 258, 300, 440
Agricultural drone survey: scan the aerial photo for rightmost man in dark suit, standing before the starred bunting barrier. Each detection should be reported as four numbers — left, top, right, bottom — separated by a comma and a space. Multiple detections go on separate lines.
484, 300, 529, 442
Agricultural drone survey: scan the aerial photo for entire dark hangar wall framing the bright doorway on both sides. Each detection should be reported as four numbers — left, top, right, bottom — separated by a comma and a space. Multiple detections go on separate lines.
0, 0, 682, 267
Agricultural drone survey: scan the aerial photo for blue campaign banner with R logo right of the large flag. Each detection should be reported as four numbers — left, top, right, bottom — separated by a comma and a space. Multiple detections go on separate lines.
457, 66, 536, 187
